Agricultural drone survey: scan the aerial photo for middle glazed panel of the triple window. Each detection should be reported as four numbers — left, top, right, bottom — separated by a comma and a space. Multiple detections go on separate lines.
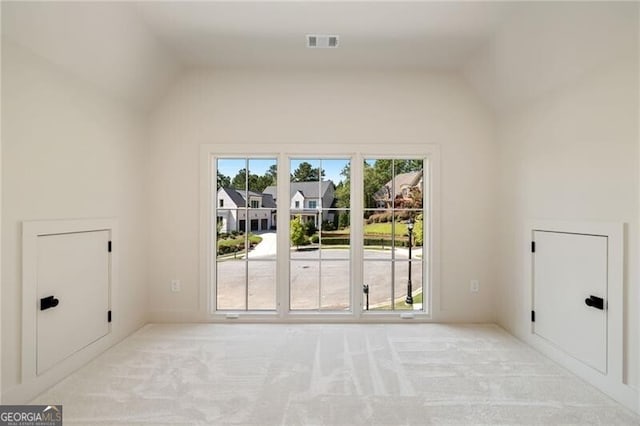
289, 158, 351, 311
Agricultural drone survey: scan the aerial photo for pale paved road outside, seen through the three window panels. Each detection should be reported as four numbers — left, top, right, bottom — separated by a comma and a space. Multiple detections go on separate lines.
217, 233, 422, 310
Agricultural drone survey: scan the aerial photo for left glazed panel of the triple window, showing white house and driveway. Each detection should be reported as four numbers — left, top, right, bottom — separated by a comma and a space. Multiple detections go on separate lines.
215, 157, 277, 311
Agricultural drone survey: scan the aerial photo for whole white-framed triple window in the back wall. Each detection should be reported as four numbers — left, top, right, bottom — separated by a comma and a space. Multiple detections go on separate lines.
202, 145, 438, 321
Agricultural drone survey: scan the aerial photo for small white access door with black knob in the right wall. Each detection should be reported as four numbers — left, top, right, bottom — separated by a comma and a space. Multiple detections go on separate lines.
533, 231, 607, 373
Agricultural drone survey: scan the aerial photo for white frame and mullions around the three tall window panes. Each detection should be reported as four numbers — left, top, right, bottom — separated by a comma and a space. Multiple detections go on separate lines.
199, 143, 440, 322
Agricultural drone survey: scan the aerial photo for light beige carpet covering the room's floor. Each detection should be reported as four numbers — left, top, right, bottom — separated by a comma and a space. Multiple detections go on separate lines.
33, 324, 640, 425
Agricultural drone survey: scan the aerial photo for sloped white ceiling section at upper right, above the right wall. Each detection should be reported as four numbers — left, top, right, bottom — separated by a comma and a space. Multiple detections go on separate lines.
465, 1, 639, 112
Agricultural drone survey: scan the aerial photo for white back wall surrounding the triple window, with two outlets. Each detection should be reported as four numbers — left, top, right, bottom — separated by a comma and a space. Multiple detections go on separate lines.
149, 71, 496, 322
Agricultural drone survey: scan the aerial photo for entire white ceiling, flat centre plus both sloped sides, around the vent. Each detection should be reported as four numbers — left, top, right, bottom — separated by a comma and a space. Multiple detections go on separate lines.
1, 0, 639, 108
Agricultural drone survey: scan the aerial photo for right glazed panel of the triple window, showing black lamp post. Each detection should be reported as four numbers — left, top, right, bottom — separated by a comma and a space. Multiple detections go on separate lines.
363, 158, 425, 311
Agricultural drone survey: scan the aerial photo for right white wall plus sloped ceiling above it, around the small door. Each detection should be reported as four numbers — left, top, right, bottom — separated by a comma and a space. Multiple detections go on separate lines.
465, 2, 640, 400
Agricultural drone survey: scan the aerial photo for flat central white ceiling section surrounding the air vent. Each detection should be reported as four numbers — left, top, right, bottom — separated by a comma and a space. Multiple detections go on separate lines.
136, 2, 510, 70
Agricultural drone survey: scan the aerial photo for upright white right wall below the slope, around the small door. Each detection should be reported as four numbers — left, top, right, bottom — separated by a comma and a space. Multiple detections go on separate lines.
497, 56, 639, 390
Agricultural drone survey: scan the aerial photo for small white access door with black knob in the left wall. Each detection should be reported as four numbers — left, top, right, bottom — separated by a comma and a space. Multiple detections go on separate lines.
36, 231, 110, 374
